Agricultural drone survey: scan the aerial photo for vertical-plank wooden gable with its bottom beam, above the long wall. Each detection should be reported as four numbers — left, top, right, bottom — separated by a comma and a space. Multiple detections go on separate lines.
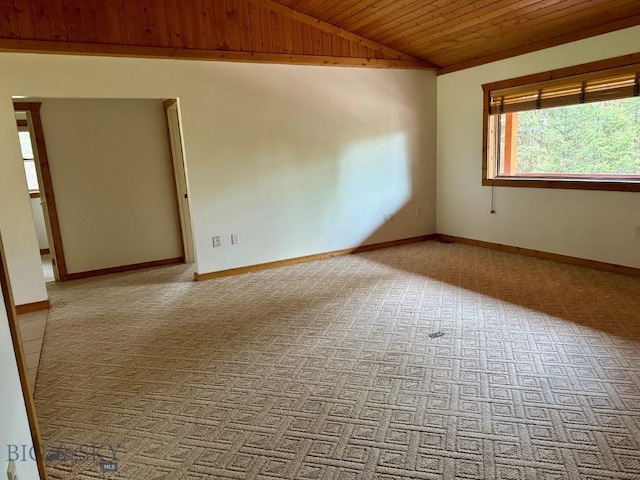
0, 0, 434, 68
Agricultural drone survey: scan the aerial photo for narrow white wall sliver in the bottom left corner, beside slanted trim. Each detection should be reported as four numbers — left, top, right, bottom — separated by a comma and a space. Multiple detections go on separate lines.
0, 284, 40, 480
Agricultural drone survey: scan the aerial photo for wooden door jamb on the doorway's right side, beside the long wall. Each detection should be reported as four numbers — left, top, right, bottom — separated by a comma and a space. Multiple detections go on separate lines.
162, 98, 196, 263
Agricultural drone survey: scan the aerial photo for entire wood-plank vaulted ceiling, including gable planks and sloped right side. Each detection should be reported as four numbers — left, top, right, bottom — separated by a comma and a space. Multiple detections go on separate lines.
0, 0, 640, 73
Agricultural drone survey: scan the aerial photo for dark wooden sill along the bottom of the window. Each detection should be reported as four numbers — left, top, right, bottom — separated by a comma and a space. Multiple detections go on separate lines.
482, 176, 640, 192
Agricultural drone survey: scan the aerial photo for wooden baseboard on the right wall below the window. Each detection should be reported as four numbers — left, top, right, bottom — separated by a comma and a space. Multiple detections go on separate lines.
437, 233, 640, 277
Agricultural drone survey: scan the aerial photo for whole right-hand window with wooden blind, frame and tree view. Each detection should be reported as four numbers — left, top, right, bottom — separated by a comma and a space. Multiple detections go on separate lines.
483, 54, 640, 191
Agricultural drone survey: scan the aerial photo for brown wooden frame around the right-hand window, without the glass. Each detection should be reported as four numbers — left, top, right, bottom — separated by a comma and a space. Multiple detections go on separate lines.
482, 52, 640, 192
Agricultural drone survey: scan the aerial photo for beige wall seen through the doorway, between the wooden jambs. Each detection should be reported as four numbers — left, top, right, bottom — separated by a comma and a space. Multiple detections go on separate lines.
40, 99, 182, 273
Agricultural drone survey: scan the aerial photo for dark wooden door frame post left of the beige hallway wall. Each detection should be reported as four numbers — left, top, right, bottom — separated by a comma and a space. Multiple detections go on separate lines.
13, 102, 68, 281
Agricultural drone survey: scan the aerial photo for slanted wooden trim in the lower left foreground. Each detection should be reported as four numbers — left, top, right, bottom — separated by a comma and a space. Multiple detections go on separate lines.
0, 231, 49, 480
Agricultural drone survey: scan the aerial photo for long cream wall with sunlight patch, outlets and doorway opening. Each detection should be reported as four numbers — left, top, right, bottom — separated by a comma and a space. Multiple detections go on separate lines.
0, 53, 436, 301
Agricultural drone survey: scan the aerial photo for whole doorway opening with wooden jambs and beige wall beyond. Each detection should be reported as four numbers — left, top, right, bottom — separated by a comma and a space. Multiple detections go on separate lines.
14, 99, 195, 281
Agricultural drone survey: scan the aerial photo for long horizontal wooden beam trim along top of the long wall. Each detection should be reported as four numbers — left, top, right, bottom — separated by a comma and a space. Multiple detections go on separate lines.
0, 39, 437, 70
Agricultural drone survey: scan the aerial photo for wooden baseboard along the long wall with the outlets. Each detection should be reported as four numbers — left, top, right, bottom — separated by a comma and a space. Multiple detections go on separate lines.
193, 234, 436, 282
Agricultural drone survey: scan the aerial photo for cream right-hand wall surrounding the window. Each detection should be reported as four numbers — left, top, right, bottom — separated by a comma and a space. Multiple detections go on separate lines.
437, 27, 640, 267
